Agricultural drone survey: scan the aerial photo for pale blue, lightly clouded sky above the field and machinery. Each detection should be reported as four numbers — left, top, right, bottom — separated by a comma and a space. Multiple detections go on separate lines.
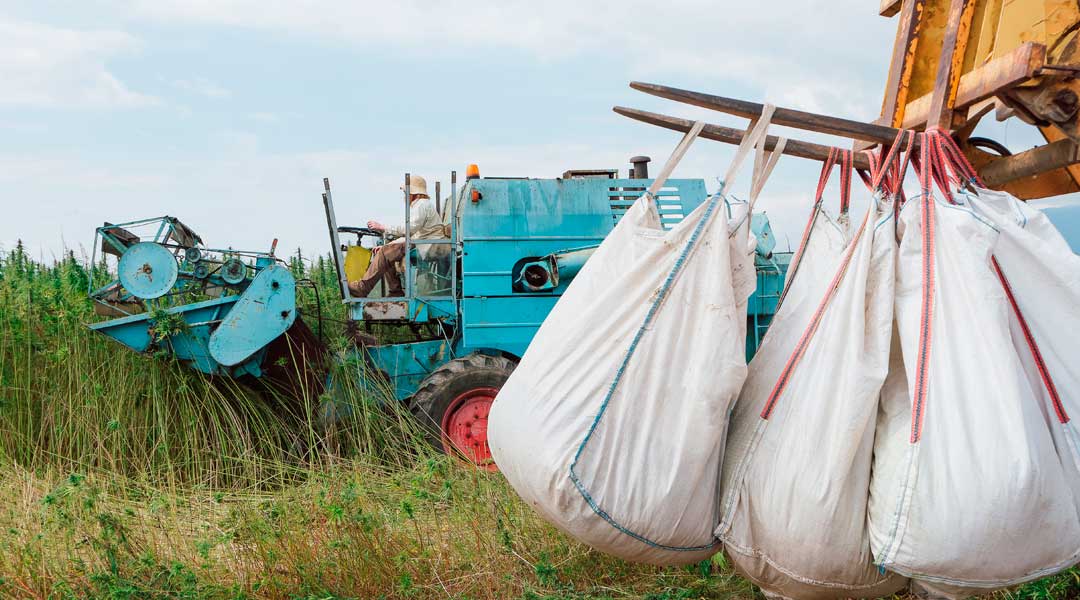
0, 0, 1075, 259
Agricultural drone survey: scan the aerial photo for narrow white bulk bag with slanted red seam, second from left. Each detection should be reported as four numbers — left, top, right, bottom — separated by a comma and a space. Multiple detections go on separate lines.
717, 146, 906, 599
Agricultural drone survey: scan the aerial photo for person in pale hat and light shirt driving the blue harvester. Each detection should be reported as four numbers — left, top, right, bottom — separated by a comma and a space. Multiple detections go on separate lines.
349, 175, 445, 298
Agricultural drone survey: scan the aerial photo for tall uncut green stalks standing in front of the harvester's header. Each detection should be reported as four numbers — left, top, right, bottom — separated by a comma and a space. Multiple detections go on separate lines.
0, 242, 415, 487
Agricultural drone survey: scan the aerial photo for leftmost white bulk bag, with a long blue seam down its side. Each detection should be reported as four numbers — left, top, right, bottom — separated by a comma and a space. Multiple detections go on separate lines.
488, 113, 779, 564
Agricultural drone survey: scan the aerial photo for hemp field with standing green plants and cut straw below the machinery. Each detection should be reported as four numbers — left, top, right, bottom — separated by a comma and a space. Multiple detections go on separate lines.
0, 240, 1080, 600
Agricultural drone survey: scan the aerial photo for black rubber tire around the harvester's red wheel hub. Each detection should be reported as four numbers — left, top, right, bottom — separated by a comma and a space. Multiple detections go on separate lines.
409, 353, 517, 462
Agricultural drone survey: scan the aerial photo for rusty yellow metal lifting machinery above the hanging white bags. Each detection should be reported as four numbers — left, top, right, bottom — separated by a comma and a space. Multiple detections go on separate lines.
876, 0, 1080, 199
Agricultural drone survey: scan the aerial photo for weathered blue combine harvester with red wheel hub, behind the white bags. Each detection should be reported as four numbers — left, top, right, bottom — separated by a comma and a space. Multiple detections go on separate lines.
91, 163, 789, 468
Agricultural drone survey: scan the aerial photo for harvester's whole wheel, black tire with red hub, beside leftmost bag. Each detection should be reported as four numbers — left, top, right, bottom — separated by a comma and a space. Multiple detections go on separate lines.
409, 354, 516, 471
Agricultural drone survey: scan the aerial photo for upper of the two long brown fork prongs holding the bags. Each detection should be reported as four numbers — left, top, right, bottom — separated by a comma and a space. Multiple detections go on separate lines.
630, 81, 899, 148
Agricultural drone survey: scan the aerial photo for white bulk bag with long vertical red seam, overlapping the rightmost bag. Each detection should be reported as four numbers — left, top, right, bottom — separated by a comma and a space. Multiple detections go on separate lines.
869, 135, 1080, 597
